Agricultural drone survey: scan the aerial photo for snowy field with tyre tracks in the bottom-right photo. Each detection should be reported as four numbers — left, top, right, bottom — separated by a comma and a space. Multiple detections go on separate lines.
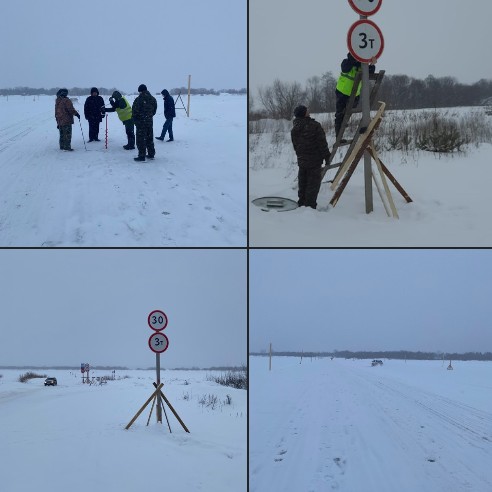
250, 357, 492, 492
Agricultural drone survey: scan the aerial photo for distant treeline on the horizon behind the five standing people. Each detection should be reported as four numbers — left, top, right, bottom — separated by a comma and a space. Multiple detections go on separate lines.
0, 87, 247, 96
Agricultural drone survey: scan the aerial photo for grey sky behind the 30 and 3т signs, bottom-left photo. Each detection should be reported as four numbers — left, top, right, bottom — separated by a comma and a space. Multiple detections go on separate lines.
0, 249, 247, 368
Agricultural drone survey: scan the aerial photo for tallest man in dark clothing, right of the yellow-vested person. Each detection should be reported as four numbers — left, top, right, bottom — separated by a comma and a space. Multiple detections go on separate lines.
132, 84, 157, 161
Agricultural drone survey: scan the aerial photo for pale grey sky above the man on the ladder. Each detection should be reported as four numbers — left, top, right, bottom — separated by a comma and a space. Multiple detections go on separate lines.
249, 0, 492, 96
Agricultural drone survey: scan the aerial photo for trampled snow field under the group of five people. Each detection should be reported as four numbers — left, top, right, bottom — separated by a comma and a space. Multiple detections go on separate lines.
0, 94, 247, 247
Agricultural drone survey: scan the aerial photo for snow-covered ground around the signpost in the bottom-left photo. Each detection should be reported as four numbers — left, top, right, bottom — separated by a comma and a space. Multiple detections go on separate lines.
0, 369, 247, 492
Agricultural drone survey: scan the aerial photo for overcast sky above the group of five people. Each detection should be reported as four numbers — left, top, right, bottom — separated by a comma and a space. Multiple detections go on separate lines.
0, 0, 247, 93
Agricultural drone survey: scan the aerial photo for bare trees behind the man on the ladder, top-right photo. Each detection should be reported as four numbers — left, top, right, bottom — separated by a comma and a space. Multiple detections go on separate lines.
249, 72, 492, 120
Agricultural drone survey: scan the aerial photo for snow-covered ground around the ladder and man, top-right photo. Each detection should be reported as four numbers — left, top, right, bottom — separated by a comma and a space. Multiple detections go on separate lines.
249, 108, 492, 247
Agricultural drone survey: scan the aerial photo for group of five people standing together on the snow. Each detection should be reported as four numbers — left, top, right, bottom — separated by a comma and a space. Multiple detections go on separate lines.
55, 84, 176, 162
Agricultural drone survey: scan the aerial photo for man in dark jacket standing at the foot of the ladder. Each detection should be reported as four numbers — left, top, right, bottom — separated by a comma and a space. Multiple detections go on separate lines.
290, 105, 330, 208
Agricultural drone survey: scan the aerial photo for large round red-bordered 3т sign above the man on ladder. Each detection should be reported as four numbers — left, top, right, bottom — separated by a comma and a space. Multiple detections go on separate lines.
347, 19, 384, 63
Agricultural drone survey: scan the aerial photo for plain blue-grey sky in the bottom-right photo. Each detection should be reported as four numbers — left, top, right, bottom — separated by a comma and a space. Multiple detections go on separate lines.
249, 250, 492, 352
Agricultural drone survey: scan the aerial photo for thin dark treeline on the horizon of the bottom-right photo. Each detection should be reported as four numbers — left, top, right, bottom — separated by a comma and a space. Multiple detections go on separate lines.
250, 350, 492, 361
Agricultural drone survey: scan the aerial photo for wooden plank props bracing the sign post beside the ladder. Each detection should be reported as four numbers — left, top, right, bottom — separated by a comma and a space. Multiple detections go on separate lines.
330, 102, 412, 218
